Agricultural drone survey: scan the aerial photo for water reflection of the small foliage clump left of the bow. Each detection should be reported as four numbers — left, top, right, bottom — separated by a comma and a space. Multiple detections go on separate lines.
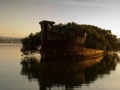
21, 57, 40, 80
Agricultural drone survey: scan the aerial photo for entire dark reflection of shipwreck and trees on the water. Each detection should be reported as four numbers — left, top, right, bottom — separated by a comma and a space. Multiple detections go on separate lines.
21, 54, 119, 90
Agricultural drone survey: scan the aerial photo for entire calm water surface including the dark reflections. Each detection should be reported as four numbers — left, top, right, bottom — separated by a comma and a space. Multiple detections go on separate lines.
0, 45, 120, 90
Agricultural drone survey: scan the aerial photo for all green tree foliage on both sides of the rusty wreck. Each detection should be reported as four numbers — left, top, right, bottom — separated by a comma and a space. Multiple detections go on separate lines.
21, 22, 119, 54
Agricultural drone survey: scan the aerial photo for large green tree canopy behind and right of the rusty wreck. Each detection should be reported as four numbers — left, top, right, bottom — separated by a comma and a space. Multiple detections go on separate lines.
53, 22, 118, 51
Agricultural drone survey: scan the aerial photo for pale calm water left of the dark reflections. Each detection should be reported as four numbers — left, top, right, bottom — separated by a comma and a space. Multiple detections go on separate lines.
0, 44, 39, 90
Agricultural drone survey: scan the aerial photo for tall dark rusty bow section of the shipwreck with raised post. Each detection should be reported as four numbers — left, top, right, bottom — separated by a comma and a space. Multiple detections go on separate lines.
39, 20, 87, 59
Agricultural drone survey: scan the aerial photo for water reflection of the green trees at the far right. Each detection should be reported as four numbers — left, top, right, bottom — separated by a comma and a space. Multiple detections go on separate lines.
84, 54, 120, 84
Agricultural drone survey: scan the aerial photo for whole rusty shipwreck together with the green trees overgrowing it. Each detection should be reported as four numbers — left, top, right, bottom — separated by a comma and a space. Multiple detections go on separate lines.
21, 21, 120, 58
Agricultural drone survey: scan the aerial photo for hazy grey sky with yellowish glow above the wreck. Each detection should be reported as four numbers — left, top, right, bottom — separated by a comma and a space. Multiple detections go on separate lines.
0, 0, 120, 38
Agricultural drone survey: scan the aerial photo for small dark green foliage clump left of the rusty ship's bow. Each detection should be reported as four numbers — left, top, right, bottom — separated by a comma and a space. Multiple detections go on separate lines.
21, 32, 41, 55
